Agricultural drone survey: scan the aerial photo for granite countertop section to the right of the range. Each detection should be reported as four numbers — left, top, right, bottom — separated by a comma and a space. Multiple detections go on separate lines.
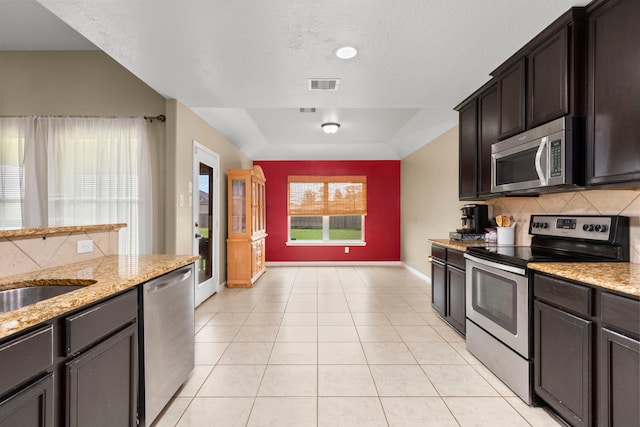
528, 262, 640, 297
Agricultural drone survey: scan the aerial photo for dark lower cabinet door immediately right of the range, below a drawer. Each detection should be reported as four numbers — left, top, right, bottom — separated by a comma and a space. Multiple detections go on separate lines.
534, 301, 593, 426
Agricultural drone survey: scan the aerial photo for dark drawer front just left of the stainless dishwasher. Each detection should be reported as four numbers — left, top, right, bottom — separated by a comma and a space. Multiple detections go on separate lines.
65, 290, 138, 356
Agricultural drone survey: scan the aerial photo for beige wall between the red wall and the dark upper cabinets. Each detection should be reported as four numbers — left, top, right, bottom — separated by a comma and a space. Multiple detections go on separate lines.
400, 126, 464, 276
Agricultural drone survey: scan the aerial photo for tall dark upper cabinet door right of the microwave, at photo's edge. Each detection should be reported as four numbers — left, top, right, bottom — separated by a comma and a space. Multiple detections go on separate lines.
586, 0, 640, 187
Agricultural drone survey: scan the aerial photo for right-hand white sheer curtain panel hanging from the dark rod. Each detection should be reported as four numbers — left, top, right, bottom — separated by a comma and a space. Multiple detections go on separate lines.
42, 117, 152, 254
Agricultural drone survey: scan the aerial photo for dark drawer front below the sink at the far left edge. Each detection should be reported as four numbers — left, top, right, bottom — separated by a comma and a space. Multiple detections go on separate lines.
0, 325, 53, 395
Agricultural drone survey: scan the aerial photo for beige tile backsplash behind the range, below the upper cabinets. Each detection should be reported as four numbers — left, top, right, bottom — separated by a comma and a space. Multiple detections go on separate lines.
487, 190, 640, 263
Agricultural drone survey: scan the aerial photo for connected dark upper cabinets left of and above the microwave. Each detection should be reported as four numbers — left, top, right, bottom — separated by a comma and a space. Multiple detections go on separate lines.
455, 7, 587, 200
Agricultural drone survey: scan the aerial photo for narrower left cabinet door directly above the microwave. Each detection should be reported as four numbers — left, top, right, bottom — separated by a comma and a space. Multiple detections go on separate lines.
497, 58, 525, 139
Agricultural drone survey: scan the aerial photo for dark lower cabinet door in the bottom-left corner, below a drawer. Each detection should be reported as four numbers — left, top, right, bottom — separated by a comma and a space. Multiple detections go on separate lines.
0, 374, 54, 427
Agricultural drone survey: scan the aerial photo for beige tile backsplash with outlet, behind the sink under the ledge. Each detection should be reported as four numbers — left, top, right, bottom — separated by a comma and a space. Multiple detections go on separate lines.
0, 229, 118, 277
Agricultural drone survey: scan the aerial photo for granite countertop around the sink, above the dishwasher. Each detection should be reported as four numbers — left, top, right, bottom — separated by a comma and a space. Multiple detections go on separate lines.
0, 255, 198, 339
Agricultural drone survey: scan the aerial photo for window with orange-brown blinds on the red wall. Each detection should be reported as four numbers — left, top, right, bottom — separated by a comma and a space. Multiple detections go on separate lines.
288, 176, 367, 244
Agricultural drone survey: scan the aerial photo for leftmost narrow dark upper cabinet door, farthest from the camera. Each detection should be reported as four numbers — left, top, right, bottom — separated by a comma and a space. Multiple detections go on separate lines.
458, 99, 478, 200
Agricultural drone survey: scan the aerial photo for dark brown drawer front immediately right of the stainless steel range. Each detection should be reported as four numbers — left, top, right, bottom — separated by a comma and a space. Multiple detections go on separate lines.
533, 275, 593, 316
